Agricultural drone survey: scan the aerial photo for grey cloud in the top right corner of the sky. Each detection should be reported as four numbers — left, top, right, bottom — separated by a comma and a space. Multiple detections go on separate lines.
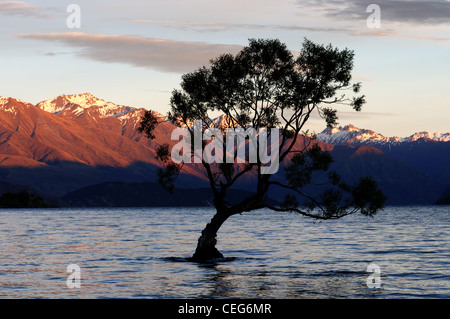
297, 0, 450, 24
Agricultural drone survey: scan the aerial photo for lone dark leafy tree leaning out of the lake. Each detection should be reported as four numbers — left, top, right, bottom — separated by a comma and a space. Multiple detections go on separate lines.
140, 39, 385, 262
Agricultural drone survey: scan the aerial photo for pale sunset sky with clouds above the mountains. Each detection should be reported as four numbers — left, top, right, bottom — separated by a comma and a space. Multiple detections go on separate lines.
0, 0, 450, 137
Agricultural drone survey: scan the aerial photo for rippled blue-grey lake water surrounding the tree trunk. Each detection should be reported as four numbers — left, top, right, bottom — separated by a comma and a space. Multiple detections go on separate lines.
0, 206, 450, 299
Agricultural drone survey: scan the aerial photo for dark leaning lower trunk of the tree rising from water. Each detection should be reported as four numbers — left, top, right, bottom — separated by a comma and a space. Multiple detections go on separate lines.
192, 210, 230, 262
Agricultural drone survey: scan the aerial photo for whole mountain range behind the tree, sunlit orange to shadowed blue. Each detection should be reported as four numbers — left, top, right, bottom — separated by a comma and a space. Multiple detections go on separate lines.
0, 93, 450, 206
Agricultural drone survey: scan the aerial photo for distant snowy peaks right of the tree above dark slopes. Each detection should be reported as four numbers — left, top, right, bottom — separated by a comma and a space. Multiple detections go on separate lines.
316, 125, 450, 146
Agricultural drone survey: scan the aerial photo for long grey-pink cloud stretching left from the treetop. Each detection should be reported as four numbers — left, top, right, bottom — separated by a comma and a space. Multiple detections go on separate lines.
18, 32, 242, 73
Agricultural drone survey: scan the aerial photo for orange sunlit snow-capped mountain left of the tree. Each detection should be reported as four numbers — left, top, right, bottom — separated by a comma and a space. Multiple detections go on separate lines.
0, 94, 207, 196
